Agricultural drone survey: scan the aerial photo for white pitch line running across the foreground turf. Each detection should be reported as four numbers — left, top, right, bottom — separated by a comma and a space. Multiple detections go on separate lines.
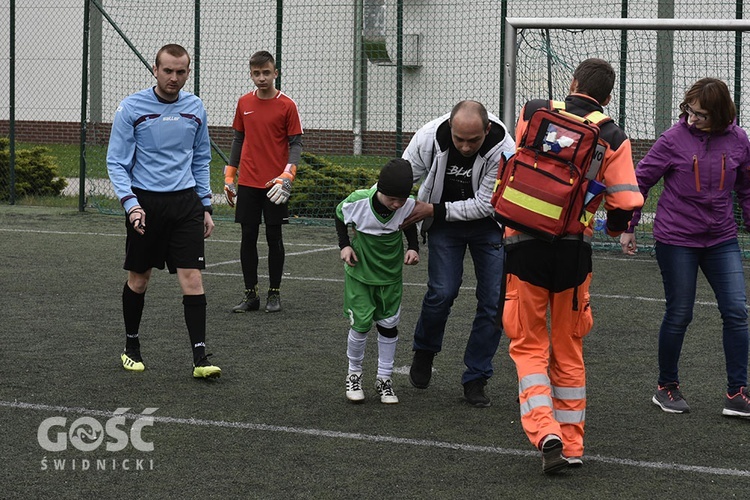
0, 401, 750, 477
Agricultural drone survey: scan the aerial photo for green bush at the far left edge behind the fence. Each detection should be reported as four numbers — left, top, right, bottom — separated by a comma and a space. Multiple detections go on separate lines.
0, 137, 68, 200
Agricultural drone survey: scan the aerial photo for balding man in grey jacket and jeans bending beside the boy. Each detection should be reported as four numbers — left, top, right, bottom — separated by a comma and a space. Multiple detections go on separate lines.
403, 100, 515, 407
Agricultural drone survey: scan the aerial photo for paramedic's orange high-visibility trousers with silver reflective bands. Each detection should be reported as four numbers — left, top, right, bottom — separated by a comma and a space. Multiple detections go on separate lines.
503, 274, 593, 457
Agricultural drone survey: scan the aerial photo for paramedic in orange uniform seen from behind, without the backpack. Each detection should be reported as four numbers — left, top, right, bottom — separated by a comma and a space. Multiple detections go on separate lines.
502, 59, 643, 473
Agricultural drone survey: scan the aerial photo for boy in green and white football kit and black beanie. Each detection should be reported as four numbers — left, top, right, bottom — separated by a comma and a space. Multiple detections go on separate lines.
336, 158, 419, 404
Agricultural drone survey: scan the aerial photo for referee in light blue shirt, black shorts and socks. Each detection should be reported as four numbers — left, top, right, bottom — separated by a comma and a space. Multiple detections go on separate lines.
107, 44, 221, 378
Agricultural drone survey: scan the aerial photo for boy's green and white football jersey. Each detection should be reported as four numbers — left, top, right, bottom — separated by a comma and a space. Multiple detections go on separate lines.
336, 186, 416, 285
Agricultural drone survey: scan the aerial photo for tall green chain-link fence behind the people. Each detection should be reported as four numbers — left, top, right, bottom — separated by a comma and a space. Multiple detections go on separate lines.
0, 0, 750, 248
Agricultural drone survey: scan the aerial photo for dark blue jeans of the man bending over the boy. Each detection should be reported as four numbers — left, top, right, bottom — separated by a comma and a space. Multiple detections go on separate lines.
414, 219, 503, 384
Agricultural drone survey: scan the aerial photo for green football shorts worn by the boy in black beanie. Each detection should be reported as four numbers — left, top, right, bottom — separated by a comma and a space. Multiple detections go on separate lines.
344, 274, 404, 333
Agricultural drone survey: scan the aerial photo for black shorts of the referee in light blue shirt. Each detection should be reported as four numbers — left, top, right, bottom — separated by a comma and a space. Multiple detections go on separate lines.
123, 189, 206, 274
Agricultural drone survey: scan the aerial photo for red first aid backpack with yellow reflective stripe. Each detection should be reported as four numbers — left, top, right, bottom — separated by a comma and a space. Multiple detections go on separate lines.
492, 101, 610, 242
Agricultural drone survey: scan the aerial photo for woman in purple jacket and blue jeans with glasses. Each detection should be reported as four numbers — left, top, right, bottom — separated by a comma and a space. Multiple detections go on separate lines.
620, 78, 750, 417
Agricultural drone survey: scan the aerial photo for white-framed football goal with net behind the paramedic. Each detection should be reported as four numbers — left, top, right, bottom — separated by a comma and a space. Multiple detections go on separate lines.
504, 18, 750, 251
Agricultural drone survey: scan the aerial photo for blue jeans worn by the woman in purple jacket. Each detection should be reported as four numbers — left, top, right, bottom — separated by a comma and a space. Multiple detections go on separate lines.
656, 239, 748, 393
